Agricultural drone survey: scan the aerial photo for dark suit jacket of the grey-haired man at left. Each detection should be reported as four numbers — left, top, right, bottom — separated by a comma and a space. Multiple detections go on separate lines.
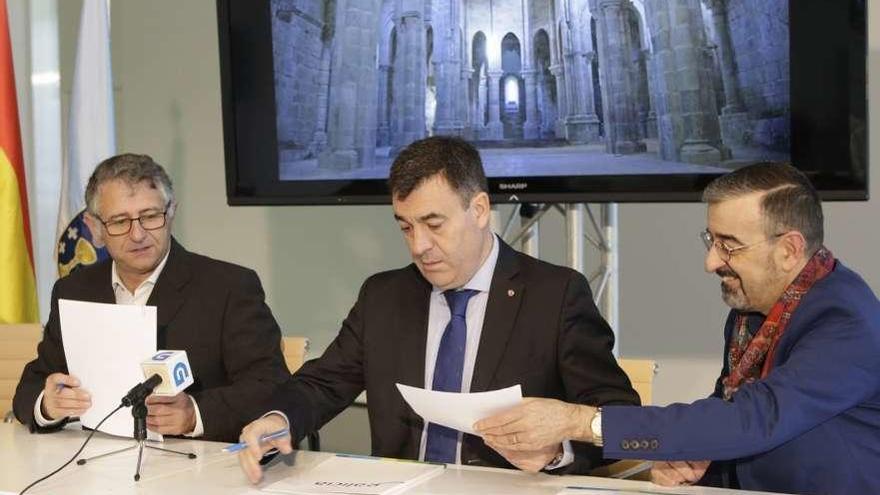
13, 240, 290, 442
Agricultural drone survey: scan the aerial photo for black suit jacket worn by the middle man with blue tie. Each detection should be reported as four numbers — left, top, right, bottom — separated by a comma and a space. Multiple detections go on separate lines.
268, 239, 639, 472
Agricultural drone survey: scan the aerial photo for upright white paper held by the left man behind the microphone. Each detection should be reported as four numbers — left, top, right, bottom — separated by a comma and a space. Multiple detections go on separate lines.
58, 299, 162, 440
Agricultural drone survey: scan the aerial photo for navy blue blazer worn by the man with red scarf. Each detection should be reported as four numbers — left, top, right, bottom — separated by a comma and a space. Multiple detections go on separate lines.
602, 261, 880, 494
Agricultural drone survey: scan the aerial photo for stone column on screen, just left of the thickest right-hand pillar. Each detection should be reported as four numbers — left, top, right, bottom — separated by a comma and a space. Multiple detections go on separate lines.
591, 0, 646, 154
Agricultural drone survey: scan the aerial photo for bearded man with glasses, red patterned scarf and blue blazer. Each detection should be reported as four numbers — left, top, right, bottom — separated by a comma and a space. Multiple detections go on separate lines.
476, 163, 880, 494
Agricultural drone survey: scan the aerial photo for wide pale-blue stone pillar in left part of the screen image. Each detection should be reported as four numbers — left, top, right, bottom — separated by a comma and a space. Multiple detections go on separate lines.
318, 0, 381, 170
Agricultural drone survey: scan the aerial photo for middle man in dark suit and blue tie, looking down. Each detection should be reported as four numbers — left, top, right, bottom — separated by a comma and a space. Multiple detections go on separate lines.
239, 137, 639, 482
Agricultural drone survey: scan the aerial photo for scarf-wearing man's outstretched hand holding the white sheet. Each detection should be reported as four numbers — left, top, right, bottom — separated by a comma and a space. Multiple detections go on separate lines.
474, 397, 595, 452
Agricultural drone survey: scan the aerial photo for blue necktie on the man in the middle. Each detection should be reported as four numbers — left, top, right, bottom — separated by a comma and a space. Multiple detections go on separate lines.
425, 289, 479, 464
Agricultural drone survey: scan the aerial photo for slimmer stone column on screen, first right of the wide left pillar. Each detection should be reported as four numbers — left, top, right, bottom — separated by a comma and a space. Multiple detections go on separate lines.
394, 5, 426, 151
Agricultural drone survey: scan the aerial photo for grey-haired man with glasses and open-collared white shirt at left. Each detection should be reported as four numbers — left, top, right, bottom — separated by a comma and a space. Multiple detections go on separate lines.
13, 154, 289, 441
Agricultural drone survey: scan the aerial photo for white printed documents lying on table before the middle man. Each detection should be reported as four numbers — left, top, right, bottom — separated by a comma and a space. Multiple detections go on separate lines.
263, 454, 446, 495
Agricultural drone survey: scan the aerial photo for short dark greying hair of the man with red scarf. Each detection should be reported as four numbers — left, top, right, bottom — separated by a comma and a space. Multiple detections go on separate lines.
703, 162, 825, 256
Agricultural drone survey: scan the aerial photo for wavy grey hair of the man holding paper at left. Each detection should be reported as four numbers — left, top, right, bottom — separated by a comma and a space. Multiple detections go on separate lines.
86, 153, 174, 216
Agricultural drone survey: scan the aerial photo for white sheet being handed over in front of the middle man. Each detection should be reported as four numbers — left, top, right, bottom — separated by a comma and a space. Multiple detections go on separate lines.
397, 383, 522, 434
